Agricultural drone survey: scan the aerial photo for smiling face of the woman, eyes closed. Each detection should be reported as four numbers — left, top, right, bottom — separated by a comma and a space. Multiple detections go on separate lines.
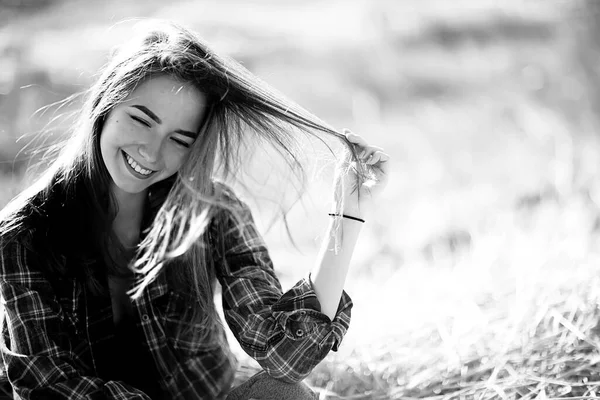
100, 75, 207, 194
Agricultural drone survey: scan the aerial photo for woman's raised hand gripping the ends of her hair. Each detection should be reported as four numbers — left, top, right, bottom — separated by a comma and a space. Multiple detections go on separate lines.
334, 129, 390, 218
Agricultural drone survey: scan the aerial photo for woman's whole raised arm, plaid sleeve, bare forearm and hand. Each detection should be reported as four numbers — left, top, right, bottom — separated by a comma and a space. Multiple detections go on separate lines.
215, 134, 388, 382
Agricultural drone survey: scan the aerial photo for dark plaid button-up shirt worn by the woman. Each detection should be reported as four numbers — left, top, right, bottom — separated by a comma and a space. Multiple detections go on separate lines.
0, 198, 352, 399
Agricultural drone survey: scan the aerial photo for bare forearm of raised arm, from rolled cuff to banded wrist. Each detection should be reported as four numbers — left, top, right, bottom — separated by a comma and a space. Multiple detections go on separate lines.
311, 196, 363, 320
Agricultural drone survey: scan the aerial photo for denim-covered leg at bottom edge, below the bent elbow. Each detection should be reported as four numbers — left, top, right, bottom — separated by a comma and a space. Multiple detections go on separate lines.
226, 371, 319, 400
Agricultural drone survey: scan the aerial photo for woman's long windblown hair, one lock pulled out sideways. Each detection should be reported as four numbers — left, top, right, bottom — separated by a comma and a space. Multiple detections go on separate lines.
0, 22, 365, 328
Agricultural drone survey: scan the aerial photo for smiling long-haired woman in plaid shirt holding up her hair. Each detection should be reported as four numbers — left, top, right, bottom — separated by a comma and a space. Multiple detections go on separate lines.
0, 23, 389, 399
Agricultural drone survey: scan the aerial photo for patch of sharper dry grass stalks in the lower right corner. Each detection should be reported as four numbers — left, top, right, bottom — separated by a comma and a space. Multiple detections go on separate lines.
312, 266, 600, 399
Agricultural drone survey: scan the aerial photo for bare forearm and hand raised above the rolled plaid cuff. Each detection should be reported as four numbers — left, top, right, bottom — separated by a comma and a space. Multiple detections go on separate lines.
311, 131, 389, 319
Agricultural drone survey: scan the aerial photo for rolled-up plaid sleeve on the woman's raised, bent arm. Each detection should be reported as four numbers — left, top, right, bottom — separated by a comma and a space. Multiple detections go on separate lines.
216, 195, 352, 382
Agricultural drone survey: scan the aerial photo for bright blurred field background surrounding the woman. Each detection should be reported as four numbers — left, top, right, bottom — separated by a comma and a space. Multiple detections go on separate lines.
0, 0, 600, 399
